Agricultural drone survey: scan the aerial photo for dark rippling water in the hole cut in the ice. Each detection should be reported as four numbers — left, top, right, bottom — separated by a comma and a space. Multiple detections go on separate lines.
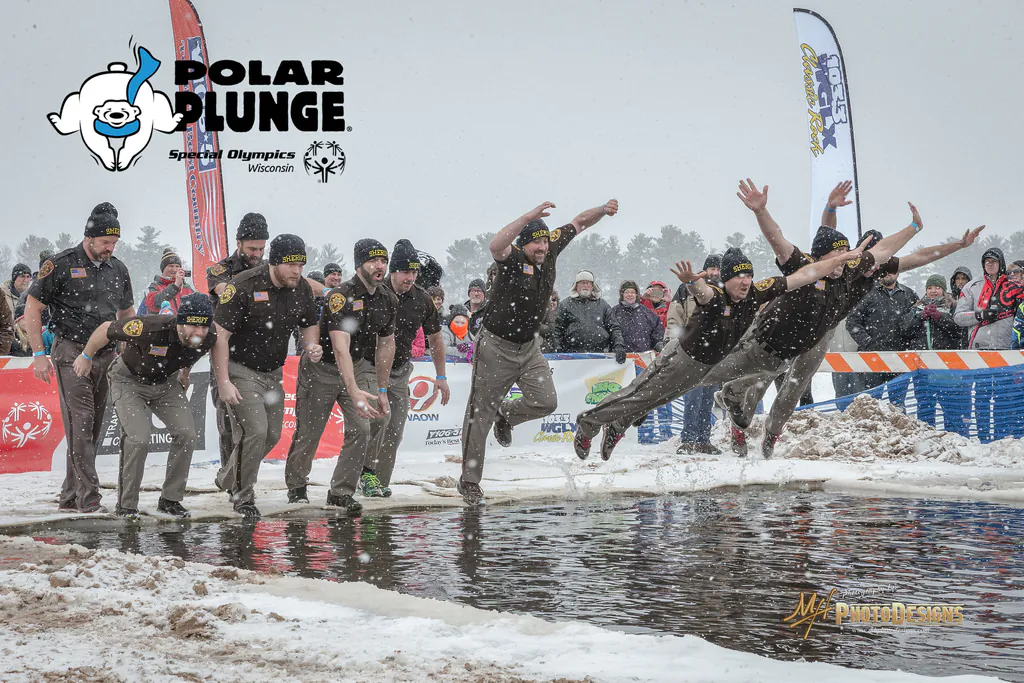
24, 488, 1024, 681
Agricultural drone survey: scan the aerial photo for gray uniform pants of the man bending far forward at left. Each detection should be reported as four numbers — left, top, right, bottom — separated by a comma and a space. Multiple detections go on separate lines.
111, 358, 196, 509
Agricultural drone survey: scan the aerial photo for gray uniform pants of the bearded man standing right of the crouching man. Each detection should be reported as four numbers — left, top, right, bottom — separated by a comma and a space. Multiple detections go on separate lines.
217, 360, 285, 508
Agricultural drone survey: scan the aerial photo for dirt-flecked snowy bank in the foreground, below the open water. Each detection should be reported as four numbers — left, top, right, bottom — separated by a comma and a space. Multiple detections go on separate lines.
0, 536, 992, 683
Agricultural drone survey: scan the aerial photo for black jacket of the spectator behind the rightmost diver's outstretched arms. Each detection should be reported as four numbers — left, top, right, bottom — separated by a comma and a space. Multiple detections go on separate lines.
846, 283, 921, 351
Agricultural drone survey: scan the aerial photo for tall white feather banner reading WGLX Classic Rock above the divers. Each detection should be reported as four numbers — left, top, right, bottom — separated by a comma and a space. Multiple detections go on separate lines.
793, 9, 860, 242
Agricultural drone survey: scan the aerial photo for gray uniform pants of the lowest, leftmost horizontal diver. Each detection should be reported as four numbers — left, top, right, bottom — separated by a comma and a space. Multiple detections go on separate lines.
577, 338, 713, 438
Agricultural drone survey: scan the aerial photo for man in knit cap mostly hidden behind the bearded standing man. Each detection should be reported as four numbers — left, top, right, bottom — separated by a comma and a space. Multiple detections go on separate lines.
206, 213, 270, 471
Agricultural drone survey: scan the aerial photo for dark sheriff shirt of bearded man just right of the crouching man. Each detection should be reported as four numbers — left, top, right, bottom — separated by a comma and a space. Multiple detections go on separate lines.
214, 264, 316, 373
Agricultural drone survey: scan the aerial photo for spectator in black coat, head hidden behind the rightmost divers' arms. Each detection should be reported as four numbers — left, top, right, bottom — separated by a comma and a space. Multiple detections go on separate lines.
846, 273, 919, 405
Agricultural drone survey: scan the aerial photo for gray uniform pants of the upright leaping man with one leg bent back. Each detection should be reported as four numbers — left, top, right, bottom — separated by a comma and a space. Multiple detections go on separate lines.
462, 328, 558, 483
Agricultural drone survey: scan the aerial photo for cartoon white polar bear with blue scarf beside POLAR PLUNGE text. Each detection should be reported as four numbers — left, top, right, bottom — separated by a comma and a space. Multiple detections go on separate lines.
46, 47, 181, 171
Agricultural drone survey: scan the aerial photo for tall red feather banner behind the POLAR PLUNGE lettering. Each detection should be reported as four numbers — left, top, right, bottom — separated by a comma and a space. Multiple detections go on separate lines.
170, 0, 228, 292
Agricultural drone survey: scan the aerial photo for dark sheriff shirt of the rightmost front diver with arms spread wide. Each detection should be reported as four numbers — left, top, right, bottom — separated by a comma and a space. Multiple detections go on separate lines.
754, 249, 899, 359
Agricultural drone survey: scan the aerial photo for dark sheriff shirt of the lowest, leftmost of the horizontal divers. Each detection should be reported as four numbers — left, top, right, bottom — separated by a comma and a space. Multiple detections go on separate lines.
679, 278, 786, 366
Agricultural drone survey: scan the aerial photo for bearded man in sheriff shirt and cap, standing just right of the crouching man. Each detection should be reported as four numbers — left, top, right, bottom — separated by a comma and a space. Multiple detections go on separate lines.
213, 234, 322, 519
